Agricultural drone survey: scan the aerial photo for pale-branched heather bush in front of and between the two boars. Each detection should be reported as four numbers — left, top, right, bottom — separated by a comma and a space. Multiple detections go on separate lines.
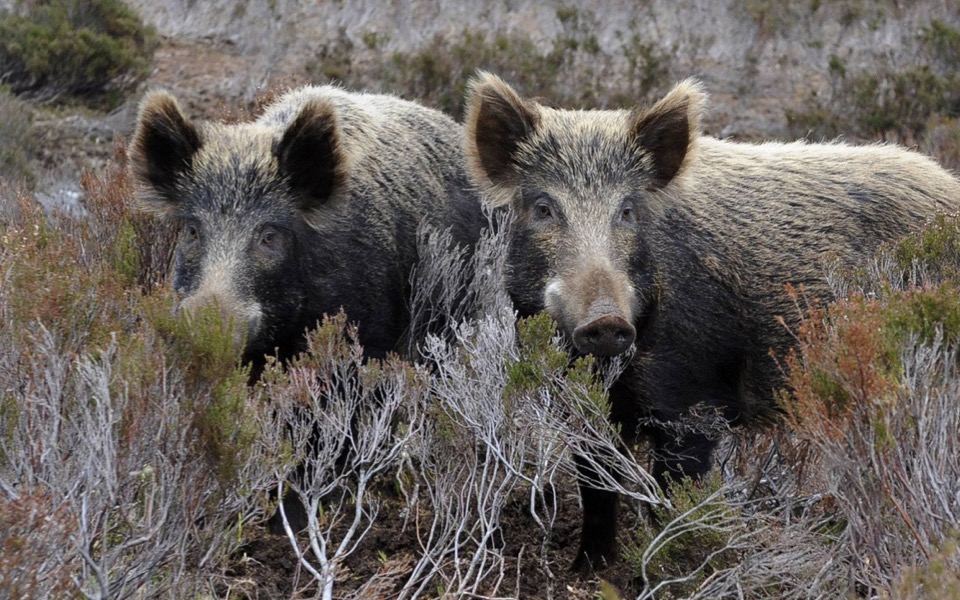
262, 217, 662, 598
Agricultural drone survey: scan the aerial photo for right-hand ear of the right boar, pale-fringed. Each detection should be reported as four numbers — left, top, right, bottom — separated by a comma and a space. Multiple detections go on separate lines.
630, 79, 706, 189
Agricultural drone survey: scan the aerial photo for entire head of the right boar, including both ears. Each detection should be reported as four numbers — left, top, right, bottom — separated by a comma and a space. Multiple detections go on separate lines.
467, 75, 694, 356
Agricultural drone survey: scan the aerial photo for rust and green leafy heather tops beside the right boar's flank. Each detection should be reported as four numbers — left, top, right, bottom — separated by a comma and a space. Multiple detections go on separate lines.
788, 215, 960, 431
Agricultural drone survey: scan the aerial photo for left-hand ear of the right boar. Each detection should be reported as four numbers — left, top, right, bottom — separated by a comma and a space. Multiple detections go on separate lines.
465, 72, 540, 206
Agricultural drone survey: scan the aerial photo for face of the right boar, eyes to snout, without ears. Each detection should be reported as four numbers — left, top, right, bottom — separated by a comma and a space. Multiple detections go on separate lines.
508, 159, 641, 356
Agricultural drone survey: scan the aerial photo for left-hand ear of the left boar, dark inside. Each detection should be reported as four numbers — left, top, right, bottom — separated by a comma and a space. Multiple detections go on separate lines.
130, 91, 202, 213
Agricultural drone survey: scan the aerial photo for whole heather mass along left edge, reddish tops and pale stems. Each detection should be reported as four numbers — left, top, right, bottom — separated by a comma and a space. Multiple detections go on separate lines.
0, 185, 278, 598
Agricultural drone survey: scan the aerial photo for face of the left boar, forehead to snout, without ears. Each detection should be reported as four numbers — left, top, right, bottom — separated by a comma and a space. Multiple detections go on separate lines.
165, 159, 316, 364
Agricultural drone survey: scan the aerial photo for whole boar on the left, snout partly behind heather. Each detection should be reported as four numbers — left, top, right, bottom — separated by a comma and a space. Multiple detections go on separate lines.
130, 86, 482, 362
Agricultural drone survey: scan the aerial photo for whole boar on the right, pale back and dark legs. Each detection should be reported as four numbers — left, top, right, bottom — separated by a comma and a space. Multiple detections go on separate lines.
464, 73, 960, 571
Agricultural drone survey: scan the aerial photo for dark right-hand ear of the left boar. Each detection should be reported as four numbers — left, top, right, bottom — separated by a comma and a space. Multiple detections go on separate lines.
274, 98, 346, 216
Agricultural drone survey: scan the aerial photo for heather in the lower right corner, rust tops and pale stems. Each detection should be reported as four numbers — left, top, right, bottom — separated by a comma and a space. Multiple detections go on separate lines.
646, 246, 960, 599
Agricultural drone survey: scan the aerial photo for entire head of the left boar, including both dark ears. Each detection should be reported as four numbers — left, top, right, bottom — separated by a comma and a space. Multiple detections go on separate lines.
131, 92, 343, 361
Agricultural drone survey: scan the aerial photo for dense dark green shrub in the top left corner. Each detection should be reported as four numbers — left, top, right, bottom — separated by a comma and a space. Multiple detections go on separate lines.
0, 0, 157, 106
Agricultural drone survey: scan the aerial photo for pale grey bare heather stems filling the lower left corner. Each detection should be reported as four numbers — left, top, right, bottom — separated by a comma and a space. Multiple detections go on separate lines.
0, 325, 276, 598
